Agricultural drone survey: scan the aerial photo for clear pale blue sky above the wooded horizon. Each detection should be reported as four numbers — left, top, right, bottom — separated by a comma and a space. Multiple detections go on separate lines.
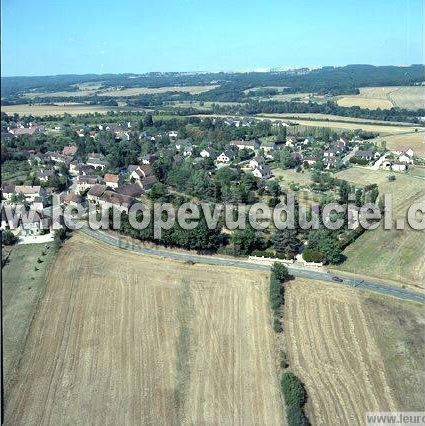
1, 0, 424, 76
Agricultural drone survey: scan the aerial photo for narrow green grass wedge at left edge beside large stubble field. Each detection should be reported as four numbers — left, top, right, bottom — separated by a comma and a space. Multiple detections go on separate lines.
2, 244, 54, 386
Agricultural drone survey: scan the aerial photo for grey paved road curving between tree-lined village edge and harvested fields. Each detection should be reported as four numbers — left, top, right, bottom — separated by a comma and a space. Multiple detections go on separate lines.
82, 226, 425, 303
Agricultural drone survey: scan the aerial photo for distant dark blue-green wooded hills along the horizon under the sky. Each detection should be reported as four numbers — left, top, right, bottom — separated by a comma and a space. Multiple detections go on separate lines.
1, 65, 425, 97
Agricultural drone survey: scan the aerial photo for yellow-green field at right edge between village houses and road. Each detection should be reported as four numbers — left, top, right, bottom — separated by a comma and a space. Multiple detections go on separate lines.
336, 167, 425, 288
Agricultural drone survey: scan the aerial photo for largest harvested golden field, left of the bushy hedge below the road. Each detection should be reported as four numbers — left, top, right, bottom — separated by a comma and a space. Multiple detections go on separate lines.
6, 233, 284, 425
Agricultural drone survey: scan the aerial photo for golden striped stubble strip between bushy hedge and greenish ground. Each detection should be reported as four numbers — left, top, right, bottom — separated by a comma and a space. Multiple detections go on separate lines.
284, 279, 398, 425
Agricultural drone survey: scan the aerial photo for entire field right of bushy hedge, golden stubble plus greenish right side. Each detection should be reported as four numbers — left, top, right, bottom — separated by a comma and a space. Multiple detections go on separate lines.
284, 279, 425, 425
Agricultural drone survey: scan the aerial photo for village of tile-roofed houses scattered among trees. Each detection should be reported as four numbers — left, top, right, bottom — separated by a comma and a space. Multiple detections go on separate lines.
1, 117, 415, 242
